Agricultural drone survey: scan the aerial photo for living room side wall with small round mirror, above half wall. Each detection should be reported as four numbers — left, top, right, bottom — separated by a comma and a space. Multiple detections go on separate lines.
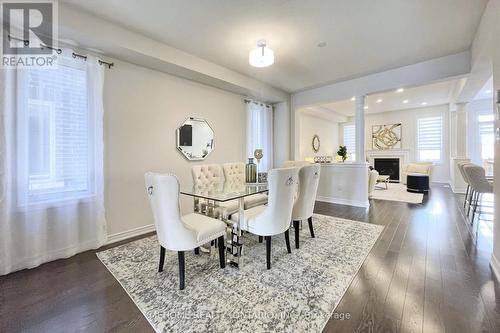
299, 114, 339, 160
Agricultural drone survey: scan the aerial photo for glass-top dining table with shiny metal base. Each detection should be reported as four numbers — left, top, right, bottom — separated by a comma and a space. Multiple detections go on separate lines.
180, 181, 268, 268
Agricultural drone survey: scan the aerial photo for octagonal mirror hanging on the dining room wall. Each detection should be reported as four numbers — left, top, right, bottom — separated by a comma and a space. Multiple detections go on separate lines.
177, 117, 214, 161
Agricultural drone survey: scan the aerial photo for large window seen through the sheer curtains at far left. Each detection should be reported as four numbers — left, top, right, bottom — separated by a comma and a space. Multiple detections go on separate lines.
18, 62, 93, 205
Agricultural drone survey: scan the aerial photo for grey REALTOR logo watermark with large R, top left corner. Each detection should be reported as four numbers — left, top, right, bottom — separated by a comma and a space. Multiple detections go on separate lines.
0, 0, 57, 68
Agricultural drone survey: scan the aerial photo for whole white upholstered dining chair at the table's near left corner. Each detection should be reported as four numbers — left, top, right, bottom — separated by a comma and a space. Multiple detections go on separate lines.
144, 172, 226, 290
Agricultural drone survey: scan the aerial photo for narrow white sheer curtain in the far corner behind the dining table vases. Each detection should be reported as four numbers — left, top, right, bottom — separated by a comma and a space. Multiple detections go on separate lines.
245, 100, 273, 172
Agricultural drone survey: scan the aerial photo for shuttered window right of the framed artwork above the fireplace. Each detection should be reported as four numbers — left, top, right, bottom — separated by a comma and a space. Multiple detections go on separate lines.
417, 117, 443, 162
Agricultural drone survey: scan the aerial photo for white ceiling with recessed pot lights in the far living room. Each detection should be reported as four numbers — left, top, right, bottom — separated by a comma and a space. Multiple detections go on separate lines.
304, 80, 460, 119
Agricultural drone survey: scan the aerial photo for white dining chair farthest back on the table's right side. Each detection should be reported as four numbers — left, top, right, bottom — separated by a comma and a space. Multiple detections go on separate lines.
292, 164, 321, 249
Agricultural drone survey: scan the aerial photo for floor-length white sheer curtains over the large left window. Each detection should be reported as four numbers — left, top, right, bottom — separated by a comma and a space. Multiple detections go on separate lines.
0, 50, 106, 275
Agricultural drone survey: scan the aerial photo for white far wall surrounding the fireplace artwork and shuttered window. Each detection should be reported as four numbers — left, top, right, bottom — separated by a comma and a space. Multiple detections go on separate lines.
356, 105, 450, 183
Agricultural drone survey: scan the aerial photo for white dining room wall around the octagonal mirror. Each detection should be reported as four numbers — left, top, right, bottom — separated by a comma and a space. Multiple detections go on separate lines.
104, 61, 245, 235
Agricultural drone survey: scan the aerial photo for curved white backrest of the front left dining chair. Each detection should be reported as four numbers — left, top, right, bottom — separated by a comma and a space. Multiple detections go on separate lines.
144, 172, 196, 251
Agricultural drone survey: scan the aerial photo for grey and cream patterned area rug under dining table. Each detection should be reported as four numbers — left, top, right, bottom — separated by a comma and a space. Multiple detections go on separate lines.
97, 214, 383, 333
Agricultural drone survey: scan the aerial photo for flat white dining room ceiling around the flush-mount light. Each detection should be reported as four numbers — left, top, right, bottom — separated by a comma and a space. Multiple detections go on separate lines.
62, 0, 487, 92
